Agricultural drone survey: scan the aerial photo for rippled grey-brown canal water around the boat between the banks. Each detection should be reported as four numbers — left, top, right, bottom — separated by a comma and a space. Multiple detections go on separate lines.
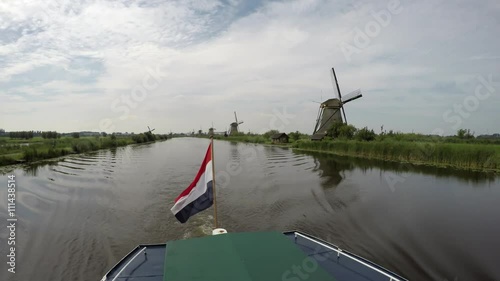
0, 138, 500, 281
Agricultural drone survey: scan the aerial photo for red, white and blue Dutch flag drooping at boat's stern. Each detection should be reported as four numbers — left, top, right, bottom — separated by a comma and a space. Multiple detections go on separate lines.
170, 143, 214, 223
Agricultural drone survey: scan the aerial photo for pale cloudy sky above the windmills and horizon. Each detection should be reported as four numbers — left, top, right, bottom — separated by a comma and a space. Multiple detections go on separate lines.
0, 0, 500, 135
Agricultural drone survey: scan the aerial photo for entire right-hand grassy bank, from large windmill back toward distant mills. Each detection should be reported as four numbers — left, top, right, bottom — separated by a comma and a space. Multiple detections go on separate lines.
193, 134, 500, 173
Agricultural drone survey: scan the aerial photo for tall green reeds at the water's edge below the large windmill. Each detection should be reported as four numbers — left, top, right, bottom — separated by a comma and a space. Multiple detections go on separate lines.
292, 140, 500, 172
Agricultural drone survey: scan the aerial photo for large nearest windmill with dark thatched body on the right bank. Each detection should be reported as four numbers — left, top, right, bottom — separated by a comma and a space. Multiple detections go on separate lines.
313, 67, 363, 140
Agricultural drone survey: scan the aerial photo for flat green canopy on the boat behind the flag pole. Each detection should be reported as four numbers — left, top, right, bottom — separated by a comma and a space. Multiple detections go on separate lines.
163, 232, 335, 281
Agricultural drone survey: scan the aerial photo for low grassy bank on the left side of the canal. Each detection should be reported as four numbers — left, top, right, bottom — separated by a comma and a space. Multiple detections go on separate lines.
0, 135, 165, 166
